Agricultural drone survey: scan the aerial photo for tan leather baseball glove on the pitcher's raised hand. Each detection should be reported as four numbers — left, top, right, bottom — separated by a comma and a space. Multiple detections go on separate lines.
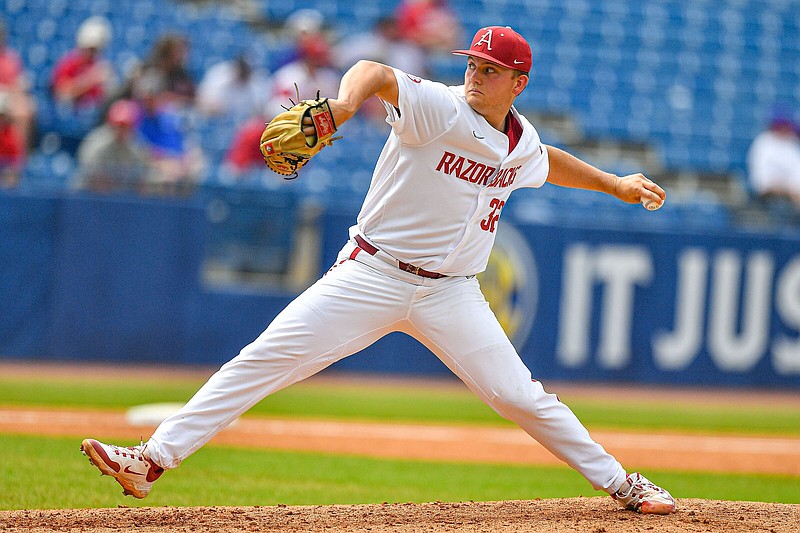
261, 94, 341, 179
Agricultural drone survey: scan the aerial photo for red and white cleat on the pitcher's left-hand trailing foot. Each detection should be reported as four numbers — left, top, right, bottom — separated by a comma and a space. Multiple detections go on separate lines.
81, 439, 164, 498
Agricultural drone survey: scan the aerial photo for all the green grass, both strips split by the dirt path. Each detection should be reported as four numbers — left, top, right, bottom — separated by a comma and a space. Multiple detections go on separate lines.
0, 375, 800, 509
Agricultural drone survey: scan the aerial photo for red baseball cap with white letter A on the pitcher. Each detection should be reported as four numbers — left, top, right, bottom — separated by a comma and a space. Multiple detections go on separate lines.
453, 26, 533, 72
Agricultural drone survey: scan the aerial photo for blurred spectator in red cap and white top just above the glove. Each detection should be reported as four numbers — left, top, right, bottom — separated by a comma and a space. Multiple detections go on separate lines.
267, 33, 341, 117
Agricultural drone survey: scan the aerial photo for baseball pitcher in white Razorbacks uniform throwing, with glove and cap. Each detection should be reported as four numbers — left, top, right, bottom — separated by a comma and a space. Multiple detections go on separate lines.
81, 26, 675, 514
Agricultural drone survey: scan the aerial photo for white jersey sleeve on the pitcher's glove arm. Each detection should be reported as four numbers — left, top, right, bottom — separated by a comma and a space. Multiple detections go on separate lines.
384, 69, 458, 145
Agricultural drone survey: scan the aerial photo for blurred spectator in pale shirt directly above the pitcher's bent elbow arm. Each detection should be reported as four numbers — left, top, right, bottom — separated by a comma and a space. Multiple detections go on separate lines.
333, 16, 428, 77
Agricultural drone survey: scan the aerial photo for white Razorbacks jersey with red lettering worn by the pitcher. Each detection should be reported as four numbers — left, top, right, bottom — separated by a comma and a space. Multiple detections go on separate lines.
350, 70, 549, 276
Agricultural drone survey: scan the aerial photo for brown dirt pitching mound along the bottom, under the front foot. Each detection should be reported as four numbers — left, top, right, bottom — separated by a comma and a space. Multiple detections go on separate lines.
0, 498, 800, 533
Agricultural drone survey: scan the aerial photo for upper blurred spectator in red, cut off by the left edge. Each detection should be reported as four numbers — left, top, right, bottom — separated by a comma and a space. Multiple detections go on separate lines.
0, 21, 36, 150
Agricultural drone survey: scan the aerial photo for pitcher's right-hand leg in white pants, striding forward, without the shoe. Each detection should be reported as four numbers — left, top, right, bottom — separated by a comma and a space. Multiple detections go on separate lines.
412, 279, 626, 492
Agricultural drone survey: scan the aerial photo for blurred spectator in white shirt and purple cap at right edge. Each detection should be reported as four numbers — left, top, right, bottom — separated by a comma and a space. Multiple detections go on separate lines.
747, 110, 800, 207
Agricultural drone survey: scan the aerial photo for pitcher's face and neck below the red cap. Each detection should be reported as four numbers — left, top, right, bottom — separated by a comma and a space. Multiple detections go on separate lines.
464, 56, 528, 125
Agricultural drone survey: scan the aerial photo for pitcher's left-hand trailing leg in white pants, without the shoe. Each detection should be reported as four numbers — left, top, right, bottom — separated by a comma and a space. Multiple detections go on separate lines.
147, 261, 410, 468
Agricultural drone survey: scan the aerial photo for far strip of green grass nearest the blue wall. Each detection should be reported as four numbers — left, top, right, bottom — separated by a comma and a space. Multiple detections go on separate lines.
0, 377, 800, 435
